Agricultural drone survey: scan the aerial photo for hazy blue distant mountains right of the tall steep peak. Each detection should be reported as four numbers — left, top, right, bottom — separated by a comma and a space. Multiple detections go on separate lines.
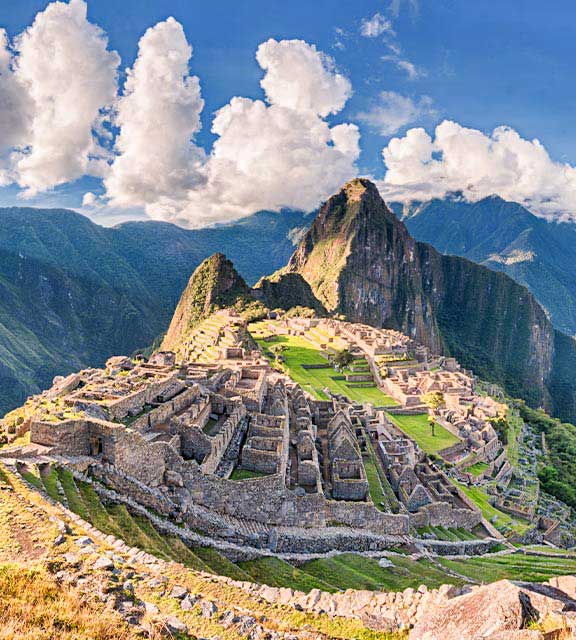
402, 196, 576, 335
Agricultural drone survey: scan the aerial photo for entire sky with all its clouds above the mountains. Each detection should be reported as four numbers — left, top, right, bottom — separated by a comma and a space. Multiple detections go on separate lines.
0, 0, 576, 227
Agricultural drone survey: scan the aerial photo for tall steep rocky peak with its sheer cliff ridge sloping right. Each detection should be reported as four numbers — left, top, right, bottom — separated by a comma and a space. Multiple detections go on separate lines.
285, 179, 554, 403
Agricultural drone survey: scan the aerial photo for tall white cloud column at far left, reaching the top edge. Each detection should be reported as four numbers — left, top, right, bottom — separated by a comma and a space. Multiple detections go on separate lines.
14, 0, 120, 195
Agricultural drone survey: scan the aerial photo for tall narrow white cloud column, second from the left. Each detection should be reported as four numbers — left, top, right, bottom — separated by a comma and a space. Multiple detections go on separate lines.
105, 18, 204, 210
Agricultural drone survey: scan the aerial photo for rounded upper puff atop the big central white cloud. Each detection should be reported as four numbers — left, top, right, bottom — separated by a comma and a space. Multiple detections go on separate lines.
256, 38, 352, 117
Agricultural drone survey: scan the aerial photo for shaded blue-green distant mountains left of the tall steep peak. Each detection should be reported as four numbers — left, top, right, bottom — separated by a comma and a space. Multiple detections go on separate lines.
0, 207, 309, 416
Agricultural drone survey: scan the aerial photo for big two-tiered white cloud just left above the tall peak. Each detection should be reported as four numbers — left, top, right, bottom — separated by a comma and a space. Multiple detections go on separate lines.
171, 40, 360, 226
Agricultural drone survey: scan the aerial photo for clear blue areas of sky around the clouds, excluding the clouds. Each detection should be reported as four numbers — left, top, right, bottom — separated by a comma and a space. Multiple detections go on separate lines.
0, 0, 576, 225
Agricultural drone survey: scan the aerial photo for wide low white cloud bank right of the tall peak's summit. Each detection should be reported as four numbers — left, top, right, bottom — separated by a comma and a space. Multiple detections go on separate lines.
381, 120, 576, 220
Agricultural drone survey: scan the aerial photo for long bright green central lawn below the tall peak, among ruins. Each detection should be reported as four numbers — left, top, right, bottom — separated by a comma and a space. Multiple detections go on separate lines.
254, 334, 396, 407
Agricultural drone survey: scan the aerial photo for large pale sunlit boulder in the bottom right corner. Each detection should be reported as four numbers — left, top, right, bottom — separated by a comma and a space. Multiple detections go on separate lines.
409, 580, 576, 640
